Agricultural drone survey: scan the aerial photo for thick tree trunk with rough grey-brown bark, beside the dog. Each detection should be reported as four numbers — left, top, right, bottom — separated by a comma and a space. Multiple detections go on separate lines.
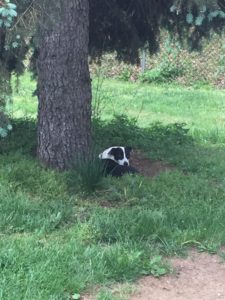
37, 0, 91, 170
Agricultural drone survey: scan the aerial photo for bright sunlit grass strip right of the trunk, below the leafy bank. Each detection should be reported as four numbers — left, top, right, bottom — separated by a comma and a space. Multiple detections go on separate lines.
94, 79, 225, 142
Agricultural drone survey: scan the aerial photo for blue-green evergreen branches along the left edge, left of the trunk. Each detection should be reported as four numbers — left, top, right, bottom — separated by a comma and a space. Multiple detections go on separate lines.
0, 0, 33, 137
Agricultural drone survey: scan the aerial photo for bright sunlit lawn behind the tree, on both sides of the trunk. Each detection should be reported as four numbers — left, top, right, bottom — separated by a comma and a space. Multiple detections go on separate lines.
9, 73, 225, 143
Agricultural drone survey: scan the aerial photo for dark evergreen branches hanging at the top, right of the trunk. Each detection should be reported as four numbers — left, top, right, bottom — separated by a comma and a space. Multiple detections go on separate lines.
90, 0, 225, 62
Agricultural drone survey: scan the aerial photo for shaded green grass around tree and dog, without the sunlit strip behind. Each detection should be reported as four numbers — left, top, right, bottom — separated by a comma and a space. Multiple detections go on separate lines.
0, 116, 225, 299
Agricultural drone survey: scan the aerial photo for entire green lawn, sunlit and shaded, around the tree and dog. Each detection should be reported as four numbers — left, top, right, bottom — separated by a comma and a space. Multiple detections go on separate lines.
0, 74, 225, 300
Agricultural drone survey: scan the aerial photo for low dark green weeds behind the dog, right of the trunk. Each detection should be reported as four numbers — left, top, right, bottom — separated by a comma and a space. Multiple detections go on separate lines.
93, 115, 193, 152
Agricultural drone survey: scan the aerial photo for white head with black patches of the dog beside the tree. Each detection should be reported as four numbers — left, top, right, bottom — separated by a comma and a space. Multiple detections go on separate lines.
99, 146, 132, 166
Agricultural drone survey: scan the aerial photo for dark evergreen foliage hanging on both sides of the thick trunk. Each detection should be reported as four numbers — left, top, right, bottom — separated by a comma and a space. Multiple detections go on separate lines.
0, 0, 225, 135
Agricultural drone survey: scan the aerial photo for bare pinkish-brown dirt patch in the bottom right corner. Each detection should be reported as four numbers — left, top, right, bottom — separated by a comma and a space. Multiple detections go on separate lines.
129, 251, 225, 300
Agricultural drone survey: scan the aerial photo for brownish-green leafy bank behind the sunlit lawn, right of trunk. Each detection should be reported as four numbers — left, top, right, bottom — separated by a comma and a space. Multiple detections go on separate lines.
90, 32, 225, 88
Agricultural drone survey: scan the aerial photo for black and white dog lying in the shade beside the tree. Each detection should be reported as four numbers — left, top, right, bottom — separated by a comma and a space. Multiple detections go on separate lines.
99, 146, 138, 177
